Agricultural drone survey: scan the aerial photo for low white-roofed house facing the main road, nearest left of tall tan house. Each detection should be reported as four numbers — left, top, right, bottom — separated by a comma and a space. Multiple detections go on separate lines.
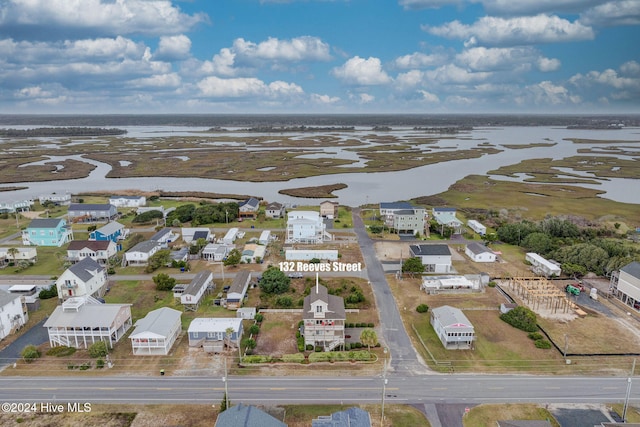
187, 317, 243, 353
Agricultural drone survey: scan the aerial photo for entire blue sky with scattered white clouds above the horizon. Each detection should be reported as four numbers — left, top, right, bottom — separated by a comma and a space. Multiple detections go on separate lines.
0, 0, 640, 114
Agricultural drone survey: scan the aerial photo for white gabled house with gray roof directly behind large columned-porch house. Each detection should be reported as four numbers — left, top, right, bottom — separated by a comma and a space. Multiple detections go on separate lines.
56, 257, 107, 301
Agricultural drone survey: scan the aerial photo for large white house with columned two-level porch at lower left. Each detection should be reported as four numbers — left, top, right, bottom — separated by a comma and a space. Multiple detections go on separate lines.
44, 296, 131, 348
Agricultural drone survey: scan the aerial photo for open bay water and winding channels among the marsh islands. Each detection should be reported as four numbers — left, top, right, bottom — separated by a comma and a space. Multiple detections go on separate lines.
0, 116, 640, 206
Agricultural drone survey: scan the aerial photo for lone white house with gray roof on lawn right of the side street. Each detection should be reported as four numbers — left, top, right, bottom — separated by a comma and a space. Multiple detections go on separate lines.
431, 305, 476, 350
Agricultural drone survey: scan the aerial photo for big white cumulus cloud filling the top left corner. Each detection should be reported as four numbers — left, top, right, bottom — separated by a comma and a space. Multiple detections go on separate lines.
0, 0, 208, 39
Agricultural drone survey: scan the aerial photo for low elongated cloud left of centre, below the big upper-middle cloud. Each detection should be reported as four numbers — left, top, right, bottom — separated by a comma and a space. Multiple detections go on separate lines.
198, 76, 303, 98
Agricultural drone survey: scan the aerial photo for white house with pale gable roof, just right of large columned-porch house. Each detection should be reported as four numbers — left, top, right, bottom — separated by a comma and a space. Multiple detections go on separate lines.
129, 307, 182, 356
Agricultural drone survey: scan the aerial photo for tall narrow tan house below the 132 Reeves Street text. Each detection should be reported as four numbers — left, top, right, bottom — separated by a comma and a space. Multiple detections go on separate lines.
302, 277, 347, 351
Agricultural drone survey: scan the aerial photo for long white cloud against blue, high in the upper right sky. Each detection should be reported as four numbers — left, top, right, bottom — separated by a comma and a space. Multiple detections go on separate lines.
422, 15, 594, 46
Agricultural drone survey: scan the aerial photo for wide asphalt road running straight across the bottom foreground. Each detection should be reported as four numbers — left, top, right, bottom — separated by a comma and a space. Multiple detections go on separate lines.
0, 376, 640, 406
